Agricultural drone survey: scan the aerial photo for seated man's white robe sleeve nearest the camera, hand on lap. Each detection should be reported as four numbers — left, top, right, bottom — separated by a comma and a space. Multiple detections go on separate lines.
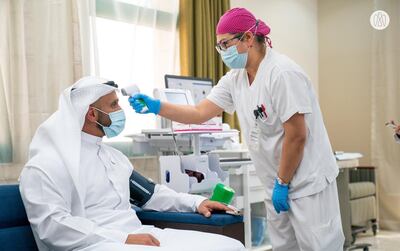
20, 168, 128, 250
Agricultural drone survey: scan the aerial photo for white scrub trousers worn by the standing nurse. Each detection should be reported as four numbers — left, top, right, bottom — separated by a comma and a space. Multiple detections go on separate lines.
265, 181, 344, 251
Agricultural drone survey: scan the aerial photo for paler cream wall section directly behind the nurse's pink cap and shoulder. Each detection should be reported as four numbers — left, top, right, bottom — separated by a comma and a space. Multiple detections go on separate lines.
231, 0, 319, 93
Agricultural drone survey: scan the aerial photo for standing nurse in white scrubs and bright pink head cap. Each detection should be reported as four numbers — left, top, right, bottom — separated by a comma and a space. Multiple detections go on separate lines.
129, 8, 344, 251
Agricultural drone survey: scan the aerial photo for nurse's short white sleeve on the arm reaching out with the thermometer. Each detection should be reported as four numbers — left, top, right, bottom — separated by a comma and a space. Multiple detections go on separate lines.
207, 72, 235, 114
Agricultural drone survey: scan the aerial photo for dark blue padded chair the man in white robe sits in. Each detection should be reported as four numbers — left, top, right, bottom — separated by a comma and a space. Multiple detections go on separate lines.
0, 185, 244, 251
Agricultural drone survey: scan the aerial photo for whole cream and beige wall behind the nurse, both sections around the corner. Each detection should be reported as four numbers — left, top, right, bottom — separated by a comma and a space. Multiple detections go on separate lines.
231, 0, 373, 165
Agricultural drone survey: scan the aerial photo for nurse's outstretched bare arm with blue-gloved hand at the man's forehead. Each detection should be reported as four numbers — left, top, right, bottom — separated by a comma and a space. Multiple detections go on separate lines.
129, 94, 223, 124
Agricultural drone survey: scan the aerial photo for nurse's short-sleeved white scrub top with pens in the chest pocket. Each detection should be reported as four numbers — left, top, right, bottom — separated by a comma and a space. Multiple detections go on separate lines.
207, 49, 339, 199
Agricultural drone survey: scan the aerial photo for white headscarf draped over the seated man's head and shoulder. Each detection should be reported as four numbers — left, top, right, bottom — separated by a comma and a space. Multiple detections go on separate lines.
25, 77, 118, 204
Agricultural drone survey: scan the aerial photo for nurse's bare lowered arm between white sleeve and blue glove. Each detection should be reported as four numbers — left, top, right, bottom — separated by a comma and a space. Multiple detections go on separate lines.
278, 113, 307, 183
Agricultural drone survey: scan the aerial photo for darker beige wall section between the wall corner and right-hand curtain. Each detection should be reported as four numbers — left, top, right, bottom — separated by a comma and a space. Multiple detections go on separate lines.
318, 0, 374, 165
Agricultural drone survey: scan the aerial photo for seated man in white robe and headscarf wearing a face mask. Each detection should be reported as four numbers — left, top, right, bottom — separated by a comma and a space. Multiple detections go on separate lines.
20, 77, 244, 251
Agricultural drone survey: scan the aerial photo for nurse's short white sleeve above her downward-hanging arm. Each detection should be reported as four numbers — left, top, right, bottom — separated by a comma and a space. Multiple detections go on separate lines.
271, 71, 312, 123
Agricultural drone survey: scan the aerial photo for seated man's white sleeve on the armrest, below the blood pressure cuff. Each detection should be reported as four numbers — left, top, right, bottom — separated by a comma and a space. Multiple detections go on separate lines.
143, 184, 207, 212
